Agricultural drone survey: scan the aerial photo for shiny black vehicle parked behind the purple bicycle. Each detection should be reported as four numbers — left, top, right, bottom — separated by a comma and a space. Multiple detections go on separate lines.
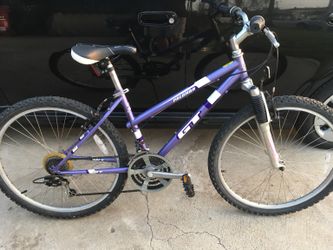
0, 0, 333, 135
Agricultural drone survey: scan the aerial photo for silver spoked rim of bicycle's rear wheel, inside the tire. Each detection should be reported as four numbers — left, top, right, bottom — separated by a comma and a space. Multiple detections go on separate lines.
0, 107, 119, 212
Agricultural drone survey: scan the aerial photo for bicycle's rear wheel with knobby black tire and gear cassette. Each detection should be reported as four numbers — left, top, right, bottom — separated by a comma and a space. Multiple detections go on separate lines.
0, 97, 128, 218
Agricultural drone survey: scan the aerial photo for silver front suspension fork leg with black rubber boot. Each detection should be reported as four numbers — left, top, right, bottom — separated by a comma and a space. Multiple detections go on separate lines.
247, 85, 285, 171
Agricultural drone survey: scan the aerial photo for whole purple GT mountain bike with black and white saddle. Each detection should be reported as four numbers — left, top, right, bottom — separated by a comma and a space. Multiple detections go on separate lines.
0, 5, 333, 218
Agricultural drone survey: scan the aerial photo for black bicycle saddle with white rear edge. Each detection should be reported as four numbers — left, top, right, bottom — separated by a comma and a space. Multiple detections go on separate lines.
71, 43, 136, 65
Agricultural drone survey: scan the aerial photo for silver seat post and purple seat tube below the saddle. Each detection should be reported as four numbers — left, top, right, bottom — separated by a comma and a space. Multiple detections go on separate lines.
107, 61, 149, 151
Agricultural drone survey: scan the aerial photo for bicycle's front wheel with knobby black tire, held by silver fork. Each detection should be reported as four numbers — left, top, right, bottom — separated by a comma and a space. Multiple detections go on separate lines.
208, 96, 333, 215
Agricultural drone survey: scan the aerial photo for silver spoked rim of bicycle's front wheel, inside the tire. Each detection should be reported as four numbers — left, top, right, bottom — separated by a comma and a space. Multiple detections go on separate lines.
218, 107, 333, 210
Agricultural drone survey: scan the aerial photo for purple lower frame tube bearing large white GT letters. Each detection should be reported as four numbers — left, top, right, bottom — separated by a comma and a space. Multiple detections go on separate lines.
158, 75, 240, 156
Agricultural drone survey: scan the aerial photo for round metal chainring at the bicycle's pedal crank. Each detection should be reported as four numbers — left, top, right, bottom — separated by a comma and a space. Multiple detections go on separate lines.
128, 153, 172, 192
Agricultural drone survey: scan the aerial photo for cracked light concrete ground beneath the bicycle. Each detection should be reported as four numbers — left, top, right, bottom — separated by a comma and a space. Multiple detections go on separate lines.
0, 129, 333, 250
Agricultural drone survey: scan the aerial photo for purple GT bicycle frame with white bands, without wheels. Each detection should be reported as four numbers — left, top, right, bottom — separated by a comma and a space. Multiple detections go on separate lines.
52, 56, 248, 175
